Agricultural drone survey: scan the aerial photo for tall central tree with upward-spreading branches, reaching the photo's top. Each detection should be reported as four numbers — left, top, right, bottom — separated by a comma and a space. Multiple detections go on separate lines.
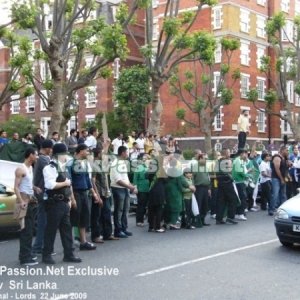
125, 0, 217, 134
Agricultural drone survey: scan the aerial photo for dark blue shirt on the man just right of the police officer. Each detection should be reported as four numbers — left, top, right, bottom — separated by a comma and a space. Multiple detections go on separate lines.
67, 159, 92, 190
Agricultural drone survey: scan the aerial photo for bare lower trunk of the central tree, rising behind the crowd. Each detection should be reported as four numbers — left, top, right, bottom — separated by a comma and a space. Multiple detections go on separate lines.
148, 80, 163, 135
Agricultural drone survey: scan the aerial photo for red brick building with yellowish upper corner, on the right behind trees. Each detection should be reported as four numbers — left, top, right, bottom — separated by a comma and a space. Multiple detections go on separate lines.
157, 0, 300, 147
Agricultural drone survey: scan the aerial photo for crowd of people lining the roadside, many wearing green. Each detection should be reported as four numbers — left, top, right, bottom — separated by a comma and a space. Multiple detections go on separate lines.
9, 128, 300, 265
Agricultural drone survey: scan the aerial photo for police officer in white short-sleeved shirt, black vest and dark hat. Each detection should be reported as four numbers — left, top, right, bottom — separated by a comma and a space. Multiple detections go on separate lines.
42, 143, 81, 264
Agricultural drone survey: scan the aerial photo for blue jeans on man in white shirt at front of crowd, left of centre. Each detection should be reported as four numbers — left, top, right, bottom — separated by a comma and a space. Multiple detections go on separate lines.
111, 187, 129, 236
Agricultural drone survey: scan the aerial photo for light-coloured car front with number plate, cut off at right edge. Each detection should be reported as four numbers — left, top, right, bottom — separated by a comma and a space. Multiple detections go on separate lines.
274, 194, 300, 247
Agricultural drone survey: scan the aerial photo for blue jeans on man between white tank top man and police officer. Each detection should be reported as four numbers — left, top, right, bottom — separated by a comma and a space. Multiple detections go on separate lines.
32, 199, 47, 253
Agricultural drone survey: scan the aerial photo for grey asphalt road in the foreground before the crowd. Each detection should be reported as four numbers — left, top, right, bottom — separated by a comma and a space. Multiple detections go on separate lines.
0, 212, 300, 300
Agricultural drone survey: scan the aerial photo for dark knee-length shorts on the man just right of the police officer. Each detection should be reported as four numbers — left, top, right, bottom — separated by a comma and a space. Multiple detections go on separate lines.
70, 190, 91, 228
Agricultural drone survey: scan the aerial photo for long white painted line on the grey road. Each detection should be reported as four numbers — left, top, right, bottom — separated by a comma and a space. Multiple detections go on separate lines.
135, 239, 278, 277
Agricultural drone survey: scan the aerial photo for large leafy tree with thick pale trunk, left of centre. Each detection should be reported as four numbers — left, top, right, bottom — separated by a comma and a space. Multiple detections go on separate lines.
12, 0, 147, 133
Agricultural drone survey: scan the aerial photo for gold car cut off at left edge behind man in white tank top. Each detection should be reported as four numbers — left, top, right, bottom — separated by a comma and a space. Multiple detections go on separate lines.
0, 183, 20, 233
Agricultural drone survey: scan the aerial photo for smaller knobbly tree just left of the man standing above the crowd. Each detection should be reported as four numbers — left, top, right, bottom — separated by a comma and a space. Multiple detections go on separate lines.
169, 32, 240, 153
